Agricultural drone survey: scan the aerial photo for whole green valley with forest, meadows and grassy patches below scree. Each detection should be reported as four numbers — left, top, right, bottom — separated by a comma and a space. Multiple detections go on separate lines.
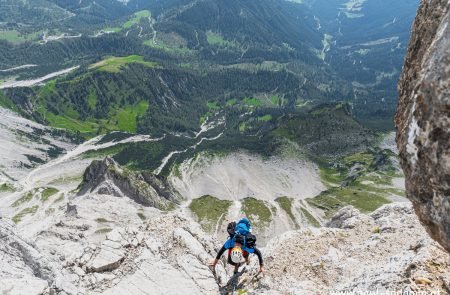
0, 0, 412, 236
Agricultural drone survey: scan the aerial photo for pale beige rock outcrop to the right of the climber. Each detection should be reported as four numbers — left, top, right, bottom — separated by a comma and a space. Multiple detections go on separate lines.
260, 203, 450, 294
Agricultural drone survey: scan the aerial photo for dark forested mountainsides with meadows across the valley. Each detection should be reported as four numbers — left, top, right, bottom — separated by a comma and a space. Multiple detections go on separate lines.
0, 0, 414, 143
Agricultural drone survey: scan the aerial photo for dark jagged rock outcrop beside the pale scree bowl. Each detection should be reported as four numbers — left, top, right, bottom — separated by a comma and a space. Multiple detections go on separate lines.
78, 157, 182, 210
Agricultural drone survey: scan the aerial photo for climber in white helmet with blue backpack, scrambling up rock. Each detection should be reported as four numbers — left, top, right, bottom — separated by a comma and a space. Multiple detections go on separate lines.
210, 218, 264, 274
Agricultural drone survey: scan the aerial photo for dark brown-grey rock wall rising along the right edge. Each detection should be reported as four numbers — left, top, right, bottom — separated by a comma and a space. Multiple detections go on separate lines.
395, 0, 450, 251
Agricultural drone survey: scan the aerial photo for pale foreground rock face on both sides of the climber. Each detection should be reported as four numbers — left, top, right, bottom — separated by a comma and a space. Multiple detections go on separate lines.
0, 187, 450, 295
